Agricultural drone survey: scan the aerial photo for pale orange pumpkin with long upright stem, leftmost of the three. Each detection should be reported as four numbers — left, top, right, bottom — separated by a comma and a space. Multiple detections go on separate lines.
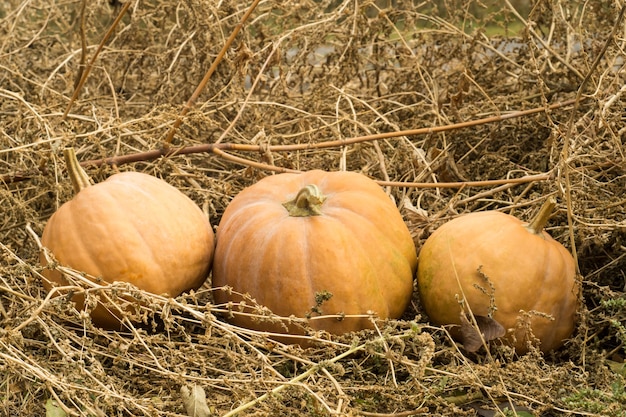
40, 148, 214, 329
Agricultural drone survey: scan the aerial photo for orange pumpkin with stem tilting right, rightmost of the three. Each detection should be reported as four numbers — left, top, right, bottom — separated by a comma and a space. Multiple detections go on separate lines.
417, 199, 579, 354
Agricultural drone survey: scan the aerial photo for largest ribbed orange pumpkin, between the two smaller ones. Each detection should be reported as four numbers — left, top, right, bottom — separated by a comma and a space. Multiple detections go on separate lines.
212, 170, 417, 345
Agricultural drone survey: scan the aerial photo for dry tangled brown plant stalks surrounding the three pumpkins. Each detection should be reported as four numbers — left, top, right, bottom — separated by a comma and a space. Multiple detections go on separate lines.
0, 0, 626, 416
